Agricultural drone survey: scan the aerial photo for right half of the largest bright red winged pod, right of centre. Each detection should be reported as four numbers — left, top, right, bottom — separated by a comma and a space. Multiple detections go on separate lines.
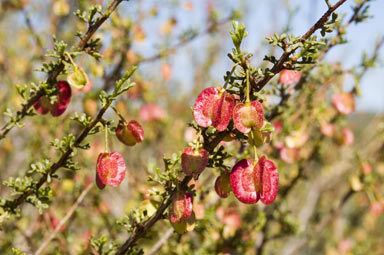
253, 156, 279, 204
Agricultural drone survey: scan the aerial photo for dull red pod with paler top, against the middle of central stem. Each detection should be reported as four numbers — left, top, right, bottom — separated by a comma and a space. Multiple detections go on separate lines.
181, 147, 209, 177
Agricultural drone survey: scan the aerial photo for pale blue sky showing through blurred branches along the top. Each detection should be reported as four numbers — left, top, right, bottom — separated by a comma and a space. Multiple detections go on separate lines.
121, 0, 384, 112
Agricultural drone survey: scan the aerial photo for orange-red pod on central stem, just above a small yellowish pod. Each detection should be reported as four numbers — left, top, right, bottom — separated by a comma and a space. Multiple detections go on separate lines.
169, 191, 193, 222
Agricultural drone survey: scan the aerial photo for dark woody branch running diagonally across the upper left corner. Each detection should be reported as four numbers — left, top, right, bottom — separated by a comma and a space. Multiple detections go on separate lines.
0, 0, 129, 140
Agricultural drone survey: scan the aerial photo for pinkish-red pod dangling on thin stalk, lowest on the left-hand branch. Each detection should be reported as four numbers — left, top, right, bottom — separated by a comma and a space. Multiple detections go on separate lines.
96, 152, 126, 189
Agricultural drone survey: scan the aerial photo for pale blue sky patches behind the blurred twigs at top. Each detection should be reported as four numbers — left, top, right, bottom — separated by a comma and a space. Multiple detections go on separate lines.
21, 0, 384, 113
